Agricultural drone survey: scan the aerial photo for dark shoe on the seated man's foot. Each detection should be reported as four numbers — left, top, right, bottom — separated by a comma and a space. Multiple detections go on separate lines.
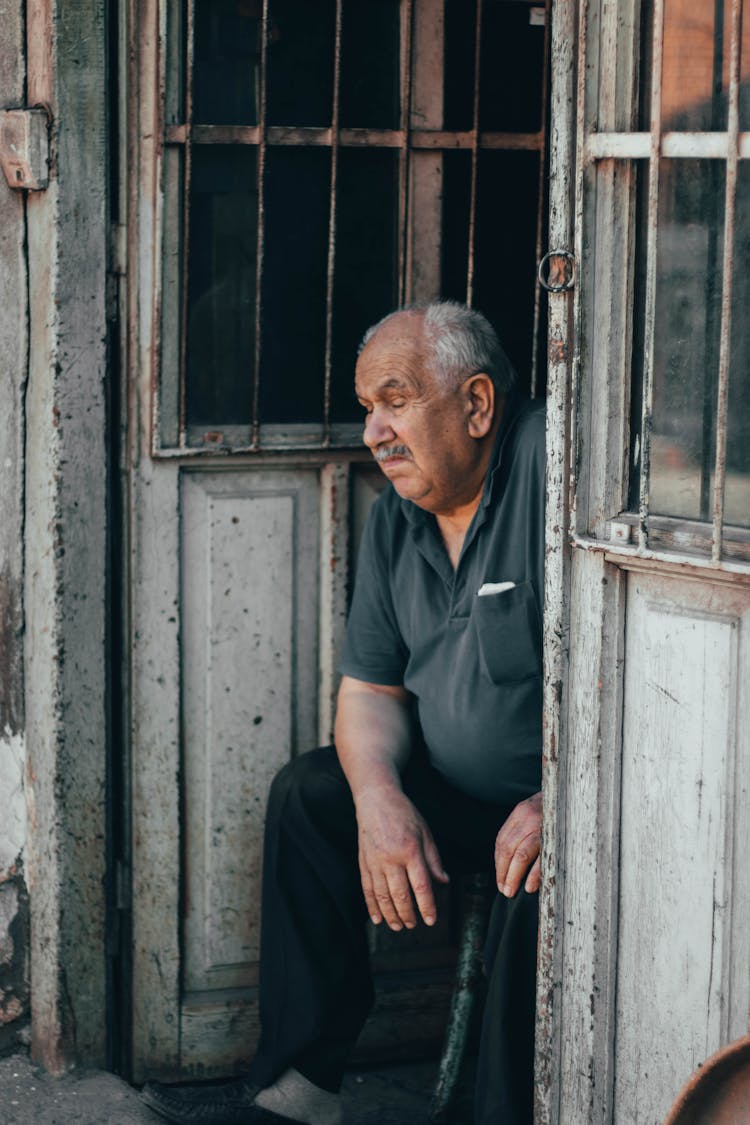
141, 1078, 299, 1125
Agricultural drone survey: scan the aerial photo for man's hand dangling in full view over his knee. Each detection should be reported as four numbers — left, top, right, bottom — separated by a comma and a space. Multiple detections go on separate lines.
356, 785, 449, 930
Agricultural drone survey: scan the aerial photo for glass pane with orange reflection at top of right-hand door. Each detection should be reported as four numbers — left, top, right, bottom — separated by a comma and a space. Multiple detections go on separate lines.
661, 0, 750, 132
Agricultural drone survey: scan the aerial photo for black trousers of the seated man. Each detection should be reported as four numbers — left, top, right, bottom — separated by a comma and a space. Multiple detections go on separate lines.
251, 746, 539, 1125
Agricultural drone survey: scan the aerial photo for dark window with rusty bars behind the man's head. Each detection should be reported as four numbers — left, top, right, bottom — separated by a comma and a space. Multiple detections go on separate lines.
153, 0, 549, 457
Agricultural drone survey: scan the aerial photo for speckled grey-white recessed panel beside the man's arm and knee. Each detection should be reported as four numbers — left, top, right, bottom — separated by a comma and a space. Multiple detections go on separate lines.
181, 469, 318, 992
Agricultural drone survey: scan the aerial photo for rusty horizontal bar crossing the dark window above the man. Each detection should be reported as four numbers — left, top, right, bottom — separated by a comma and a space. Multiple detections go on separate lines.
164, 125, 546, 156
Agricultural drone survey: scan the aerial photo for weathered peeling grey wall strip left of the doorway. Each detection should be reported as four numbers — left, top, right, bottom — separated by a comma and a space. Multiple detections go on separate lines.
0, 0, 108, 1072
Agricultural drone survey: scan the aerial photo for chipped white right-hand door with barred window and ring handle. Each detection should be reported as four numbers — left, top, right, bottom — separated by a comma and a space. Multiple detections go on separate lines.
539, 0, 750, 1123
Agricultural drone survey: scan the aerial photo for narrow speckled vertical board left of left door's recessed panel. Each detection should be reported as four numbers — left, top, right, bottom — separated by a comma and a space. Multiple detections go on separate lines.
130, 458, 181, 1081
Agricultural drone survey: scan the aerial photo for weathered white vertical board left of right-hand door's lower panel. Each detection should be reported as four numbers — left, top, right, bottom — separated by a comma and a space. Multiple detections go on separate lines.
552, 552, 624, 1125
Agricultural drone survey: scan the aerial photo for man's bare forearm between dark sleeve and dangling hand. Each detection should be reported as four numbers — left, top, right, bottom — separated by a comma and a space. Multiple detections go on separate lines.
334, 676, 412, 803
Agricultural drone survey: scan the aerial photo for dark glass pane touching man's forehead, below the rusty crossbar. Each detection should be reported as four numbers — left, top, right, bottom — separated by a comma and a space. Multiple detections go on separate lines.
331, 149, 398, 422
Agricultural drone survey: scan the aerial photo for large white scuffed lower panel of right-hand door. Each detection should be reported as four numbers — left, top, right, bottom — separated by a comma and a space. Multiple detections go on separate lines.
615, 575, 750, 1123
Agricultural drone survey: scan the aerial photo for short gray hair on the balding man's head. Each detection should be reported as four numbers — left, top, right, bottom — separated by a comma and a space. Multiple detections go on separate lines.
358, 300, 516, 395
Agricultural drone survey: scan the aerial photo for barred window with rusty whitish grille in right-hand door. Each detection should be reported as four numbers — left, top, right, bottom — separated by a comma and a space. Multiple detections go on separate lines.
576, 0, 750, 566
